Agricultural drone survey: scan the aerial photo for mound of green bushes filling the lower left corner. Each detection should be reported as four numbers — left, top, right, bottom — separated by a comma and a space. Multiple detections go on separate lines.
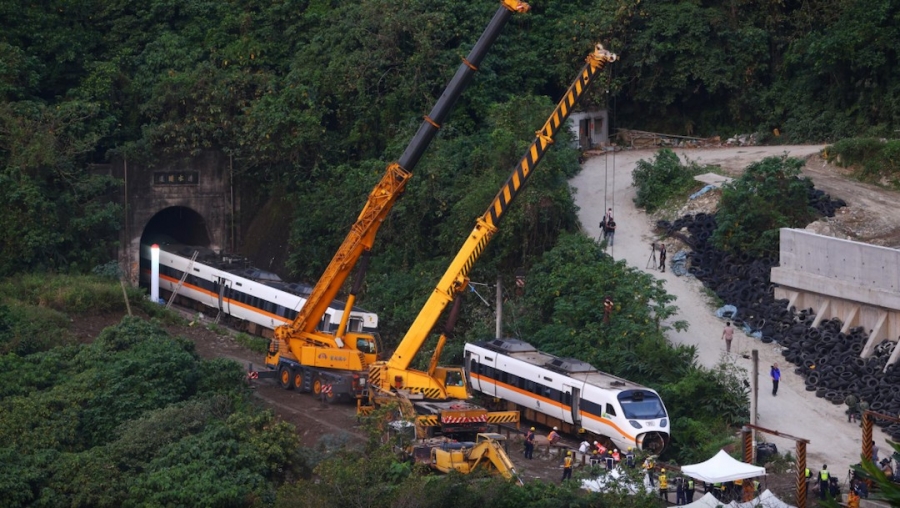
0, 318, 299, 507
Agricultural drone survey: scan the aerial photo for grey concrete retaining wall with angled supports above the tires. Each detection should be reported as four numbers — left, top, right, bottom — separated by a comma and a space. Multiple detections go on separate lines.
771, 228, 900, 363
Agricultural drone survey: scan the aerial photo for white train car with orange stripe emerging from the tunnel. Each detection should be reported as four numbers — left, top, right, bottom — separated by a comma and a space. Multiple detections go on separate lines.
141, 241, 378, 337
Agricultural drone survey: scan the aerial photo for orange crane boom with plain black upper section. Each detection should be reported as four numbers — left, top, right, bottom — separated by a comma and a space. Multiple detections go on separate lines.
266, 0, 530, 366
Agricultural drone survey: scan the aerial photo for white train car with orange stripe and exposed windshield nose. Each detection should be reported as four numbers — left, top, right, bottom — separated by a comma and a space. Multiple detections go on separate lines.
465, 339, 670, 453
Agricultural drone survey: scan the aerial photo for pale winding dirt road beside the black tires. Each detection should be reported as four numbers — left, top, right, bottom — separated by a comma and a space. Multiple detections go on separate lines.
571, 146, 900, 478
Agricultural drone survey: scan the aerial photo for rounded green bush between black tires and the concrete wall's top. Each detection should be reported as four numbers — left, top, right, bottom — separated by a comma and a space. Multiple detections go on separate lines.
712, 156, 816, 256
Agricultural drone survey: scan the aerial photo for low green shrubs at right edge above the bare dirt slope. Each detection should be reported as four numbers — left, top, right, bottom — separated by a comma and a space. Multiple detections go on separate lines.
825, 138, 900, 188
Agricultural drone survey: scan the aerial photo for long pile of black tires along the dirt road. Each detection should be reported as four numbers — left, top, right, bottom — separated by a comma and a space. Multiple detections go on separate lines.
657, 185, 900, 441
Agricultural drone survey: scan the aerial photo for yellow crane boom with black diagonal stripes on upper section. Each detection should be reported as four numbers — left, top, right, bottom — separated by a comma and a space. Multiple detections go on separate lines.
369, 44, 617, 388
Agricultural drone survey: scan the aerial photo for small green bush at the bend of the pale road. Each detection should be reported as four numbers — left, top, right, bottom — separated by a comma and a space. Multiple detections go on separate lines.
631, 148, 712, 212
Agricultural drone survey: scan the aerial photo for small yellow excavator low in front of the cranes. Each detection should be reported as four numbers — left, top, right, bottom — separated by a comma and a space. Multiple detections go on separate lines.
419, 433, 523, 485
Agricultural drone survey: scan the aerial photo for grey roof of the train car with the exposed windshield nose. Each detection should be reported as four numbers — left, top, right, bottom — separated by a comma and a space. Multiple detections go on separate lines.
475, 339, 648, 390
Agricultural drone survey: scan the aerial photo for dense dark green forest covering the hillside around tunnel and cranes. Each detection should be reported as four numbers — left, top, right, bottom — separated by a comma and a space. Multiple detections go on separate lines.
0, 0, 900, 506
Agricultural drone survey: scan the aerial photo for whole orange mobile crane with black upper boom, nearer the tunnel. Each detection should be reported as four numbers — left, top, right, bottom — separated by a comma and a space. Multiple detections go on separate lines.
250, 0, 530, 401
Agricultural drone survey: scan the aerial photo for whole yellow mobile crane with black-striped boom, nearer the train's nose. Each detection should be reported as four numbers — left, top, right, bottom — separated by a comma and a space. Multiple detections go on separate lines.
369, 44, 617, 436
